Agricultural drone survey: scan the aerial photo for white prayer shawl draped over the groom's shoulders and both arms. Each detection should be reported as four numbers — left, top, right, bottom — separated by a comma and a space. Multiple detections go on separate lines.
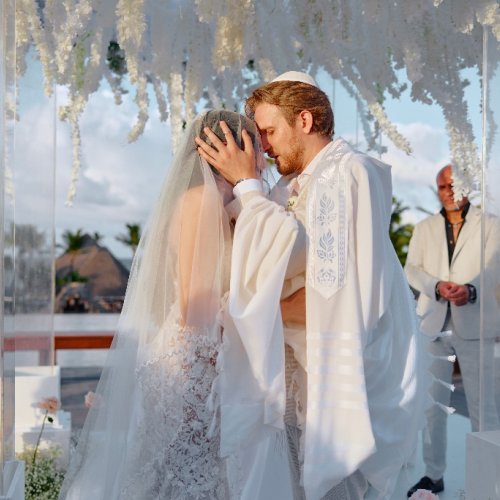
221, 139, 425, 500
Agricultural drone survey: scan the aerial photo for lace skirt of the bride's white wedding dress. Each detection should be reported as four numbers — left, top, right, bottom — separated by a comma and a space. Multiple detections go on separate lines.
120, 327, 229, 500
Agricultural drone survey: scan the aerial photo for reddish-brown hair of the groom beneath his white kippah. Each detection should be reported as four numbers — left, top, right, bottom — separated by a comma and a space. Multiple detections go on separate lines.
245, 80, 335, 137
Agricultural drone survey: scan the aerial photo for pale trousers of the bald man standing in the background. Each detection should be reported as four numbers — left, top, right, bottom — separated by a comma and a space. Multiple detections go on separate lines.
423, 319, 499, 479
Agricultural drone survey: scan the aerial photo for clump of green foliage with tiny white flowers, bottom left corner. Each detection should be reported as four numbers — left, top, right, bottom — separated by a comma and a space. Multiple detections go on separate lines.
17, 447, 64, 500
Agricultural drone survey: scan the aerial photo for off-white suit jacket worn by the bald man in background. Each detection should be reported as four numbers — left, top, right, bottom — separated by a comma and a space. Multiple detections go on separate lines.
405, 205, 500, 340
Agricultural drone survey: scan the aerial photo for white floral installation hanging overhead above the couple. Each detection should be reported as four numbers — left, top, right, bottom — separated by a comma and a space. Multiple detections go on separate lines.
16, 0, 500, 203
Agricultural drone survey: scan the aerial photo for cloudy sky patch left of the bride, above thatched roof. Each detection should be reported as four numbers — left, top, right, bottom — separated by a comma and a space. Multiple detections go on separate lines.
14, 79, 171, 257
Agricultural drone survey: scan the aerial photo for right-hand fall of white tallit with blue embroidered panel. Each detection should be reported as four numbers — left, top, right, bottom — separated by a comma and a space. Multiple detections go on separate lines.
304, 139, 425, 498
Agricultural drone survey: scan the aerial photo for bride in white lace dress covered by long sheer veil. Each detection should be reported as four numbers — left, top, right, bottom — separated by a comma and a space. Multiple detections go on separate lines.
60, 110, 260, 500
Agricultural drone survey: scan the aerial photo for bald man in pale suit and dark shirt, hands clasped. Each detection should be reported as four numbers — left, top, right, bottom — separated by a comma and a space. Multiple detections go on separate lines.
405, 165, 500, 497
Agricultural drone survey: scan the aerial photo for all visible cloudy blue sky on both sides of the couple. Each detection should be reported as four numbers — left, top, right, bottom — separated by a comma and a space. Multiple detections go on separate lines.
14, 53, 500, 258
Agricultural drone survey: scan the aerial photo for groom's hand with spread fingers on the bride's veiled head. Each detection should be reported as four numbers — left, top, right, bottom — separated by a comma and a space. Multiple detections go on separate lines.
195, 121, 258, 184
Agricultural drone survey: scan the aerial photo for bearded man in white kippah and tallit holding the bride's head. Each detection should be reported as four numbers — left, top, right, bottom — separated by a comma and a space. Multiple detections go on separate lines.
197, 72, 425, 500
